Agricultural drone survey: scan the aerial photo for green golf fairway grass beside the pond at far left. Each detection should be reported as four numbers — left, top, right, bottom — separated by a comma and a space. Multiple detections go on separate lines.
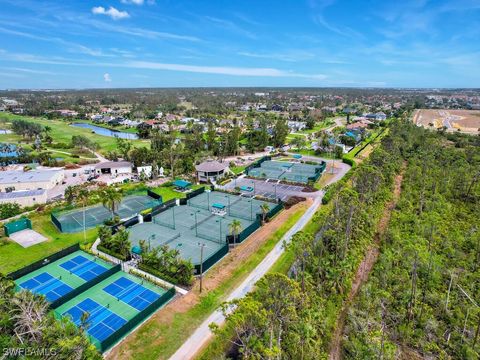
0, 113, 150, 153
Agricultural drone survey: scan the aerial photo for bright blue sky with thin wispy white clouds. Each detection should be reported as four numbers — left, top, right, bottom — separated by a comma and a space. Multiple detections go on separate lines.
0, 0, 480, 89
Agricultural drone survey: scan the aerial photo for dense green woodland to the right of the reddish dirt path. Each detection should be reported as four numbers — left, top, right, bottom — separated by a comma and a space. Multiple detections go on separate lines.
343, 125, 480, 359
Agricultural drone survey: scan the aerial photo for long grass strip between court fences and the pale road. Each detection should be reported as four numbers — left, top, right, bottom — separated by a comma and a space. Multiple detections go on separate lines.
125, 207, 306, 359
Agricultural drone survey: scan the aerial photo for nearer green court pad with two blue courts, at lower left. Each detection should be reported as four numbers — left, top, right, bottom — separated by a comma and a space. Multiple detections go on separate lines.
55, 271, 171, 350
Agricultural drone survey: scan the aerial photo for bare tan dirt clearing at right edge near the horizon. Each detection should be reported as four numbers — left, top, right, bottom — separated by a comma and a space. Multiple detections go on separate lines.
413, 109, 480, 134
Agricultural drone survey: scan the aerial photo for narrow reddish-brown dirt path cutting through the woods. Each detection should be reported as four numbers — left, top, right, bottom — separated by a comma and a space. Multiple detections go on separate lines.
328, 164, 405, 360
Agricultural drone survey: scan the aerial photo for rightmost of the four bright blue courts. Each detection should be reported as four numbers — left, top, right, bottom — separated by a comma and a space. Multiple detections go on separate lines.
103, 277, 160, 311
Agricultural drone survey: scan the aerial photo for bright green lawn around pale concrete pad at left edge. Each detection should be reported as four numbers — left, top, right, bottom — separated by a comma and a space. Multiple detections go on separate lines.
0, 213, 97, 274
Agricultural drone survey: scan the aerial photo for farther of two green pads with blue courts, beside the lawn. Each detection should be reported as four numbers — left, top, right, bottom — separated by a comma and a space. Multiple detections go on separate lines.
15, 251, 112, 302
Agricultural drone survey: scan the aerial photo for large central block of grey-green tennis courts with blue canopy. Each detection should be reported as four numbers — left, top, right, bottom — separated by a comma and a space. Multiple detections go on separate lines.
128, 191, 274, 265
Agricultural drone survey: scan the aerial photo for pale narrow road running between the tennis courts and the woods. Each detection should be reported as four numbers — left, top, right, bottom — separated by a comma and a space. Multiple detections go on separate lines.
170, 164, 349, 360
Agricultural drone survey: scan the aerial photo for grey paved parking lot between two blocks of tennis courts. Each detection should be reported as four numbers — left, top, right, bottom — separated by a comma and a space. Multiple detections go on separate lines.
225, 177, 313, 201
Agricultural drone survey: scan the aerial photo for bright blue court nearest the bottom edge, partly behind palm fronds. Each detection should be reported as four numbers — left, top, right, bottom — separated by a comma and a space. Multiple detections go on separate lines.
63, 298, 127, 341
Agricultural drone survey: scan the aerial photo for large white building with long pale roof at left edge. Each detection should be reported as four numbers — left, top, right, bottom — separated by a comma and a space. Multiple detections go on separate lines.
0, 170, 65, 192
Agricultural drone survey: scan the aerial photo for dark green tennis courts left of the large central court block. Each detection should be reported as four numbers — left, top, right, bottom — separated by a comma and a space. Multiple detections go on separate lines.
52, 195, 161, 233
